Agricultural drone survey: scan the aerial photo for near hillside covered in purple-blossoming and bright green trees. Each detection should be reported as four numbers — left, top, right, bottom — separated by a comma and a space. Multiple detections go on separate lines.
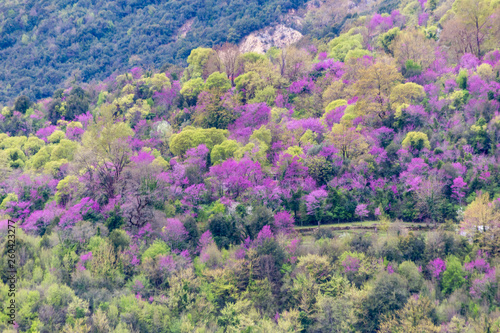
0, 0, 500, 333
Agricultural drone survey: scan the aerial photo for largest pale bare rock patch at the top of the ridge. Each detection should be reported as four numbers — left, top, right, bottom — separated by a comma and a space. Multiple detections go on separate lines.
240, 24, 302, 54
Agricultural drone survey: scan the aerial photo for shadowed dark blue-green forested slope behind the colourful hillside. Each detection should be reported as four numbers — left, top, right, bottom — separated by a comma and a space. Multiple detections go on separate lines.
0, 0, 304, 103
